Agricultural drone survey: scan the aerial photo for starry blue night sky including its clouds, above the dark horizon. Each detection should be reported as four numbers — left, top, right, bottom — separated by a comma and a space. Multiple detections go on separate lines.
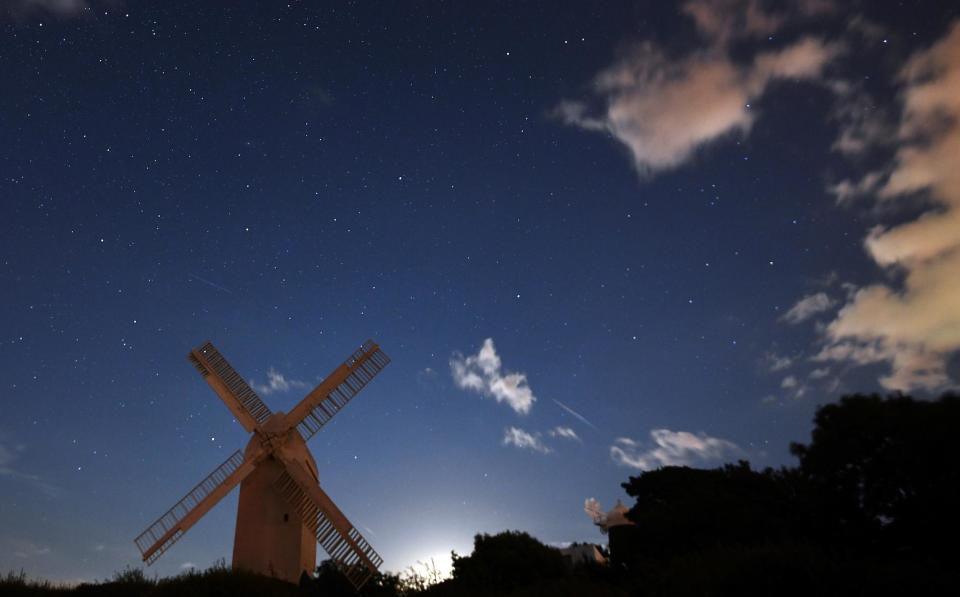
0, 0, 960, 580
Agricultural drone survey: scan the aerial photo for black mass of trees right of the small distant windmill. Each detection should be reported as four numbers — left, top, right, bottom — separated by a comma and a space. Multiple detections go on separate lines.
613, 395, 960, 595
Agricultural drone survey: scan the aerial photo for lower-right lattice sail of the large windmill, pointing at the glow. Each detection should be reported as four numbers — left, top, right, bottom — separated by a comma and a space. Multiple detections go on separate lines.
274, 461, 383, 590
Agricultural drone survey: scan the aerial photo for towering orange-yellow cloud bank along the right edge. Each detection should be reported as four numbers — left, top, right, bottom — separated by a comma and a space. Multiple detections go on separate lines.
814, 21, 960, 391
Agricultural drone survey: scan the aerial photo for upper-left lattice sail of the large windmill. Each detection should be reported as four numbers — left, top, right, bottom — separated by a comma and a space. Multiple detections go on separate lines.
187, 342, 273, 431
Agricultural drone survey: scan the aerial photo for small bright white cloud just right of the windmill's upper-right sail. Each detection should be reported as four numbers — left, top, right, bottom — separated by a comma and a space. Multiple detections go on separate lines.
450, 338, 537, 415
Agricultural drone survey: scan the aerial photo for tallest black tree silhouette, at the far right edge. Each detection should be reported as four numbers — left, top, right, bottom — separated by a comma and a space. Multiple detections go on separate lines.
790, 394, 960, 556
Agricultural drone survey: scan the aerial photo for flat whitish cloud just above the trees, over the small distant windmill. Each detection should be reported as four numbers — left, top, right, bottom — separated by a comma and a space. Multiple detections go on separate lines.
610, 429, 743, 471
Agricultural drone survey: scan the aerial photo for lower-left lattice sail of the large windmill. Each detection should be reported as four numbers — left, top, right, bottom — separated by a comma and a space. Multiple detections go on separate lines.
134, 450, 256, 564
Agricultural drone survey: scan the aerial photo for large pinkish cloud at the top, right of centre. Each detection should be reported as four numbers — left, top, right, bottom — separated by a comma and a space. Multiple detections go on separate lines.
554, 0, 839, 175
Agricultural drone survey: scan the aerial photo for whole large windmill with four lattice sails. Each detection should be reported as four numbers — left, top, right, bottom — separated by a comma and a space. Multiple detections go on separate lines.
134, 340, 390, 589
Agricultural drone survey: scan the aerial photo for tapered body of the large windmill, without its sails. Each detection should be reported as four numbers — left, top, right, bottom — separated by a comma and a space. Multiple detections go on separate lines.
233, 458, 317, 583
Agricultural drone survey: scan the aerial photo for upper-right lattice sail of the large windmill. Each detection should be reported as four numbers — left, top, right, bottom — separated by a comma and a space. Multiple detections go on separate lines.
287, 340, 390, 441
